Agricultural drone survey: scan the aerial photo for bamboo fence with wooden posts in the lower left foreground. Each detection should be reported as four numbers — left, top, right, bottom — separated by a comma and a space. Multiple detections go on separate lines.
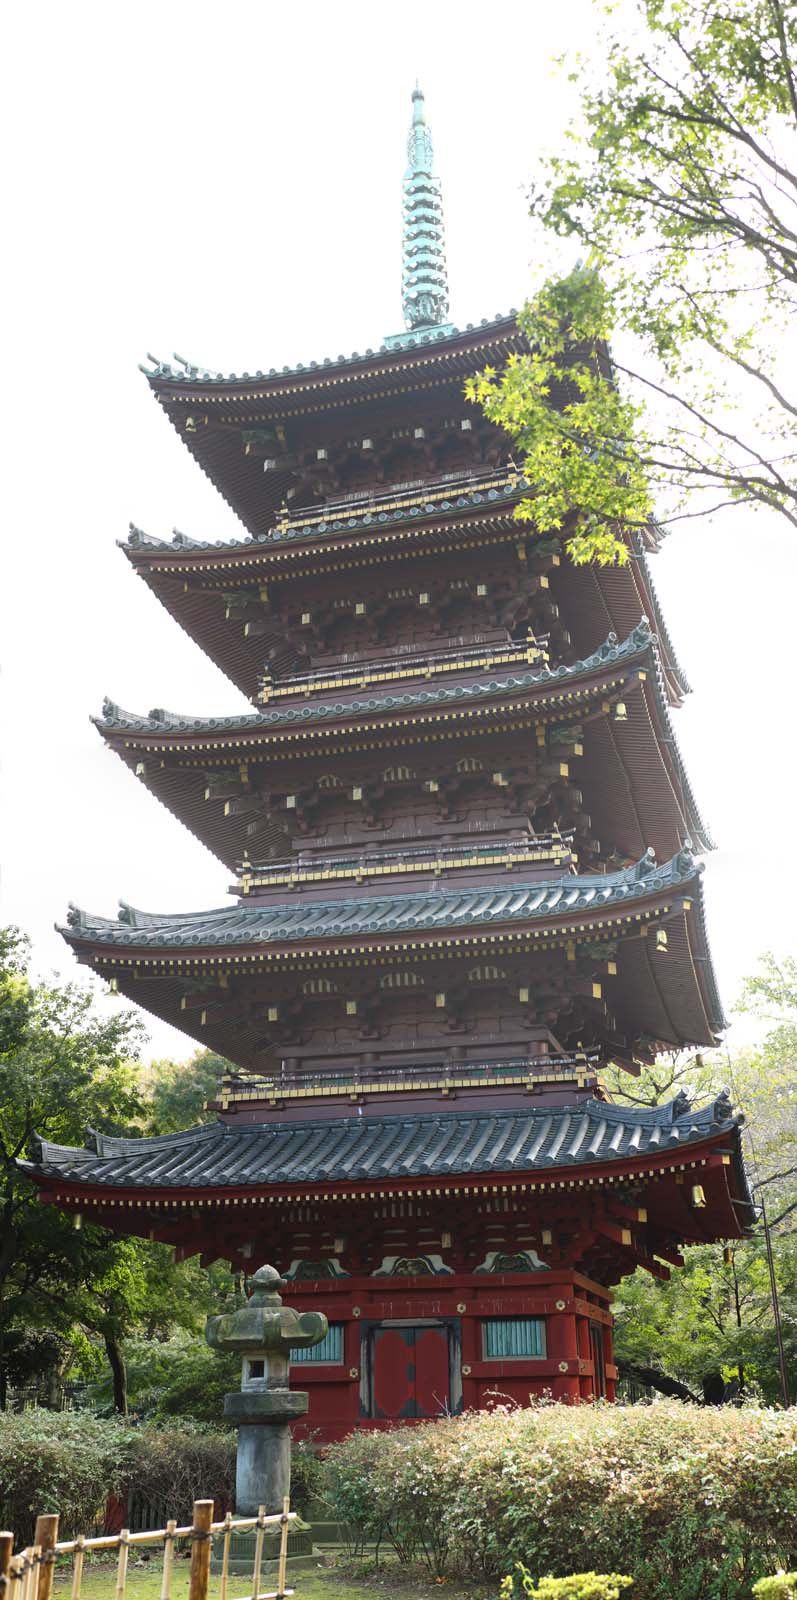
0, 1499, 298, 1600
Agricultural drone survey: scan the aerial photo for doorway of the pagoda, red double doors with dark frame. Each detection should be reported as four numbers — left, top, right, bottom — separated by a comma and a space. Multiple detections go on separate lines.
362, 1318, 463, 1421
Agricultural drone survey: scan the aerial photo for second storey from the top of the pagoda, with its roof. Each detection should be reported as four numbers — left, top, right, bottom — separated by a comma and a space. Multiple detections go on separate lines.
123, 480, 688, 706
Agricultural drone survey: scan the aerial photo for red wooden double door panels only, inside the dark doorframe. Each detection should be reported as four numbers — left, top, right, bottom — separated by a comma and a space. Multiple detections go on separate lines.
370, 1323, 450, 1418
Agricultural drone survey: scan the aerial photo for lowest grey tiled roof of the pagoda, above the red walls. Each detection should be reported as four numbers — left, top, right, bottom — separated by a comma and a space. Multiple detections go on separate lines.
22, 1091, 743, 1189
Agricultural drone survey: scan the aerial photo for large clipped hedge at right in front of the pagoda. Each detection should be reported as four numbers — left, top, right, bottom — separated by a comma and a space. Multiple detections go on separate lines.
325, 1403, 797, 1600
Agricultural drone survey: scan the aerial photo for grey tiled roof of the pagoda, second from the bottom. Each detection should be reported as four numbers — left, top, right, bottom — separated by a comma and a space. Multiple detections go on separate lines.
61, 850, 703, 949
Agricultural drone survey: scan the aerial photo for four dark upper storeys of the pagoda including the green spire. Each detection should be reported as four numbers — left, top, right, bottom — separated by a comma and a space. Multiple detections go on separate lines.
66, 94, 722, 1117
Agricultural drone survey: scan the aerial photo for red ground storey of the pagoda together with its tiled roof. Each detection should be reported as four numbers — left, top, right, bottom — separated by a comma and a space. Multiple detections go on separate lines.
26, 1094, 751, 1442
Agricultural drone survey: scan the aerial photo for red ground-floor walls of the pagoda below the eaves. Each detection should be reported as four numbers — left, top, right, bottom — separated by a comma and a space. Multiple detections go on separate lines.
283, 1258, 616, 1443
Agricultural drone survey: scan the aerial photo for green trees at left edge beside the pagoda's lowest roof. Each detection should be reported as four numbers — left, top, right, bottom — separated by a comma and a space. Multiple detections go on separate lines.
0, 930, 232, 1413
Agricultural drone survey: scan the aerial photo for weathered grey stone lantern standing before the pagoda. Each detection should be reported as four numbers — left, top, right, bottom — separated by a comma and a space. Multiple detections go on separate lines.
205, 1267, 328, 1517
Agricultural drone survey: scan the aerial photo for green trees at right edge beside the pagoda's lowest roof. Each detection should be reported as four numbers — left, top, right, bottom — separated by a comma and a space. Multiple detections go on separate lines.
611, 955, 797, 1400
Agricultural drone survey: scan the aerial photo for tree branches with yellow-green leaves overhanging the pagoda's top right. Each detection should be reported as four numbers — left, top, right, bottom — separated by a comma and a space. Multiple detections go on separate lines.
471, 0, 797, 562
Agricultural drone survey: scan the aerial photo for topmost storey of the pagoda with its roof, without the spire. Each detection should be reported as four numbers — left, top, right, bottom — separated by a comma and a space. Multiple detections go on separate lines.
141, 312, 528, 538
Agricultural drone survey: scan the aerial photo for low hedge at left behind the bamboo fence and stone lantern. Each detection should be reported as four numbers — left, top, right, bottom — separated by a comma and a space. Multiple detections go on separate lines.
0, 1410, 320, 1546
